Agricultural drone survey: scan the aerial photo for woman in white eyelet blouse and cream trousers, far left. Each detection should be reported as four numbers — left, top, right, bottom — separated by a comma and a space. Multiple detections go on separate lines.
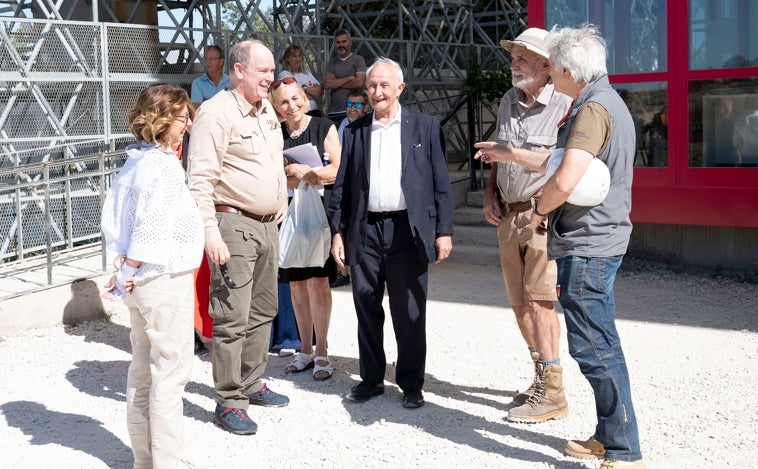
101, 84, 204, 468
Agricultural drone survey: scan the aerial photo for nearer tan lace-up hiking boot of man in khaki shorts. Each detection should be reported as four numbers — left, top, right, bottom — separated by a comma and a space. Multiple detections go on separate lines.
506, 363, 568, 423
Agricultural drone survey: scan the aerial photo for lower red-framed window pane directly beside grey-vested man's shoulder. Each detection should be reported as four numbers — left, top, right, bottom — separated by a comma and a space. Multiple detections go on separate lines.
613, 82, 668, 166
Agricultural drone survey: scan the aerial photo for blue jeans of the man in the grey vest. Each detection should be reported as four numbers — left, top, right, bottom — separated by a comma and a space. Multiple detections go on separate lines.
556, 256, 642, 461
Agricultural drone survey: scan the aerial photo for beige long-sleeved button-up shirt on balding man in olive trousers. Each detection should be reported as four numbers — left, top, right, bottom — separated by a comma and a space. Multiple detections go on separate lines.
188, 89, 287, 243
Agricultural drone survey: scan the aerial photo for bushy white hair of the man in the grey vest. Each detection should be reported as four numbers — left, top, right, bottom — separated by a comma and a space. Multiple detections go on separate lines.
545, 24, 608, 85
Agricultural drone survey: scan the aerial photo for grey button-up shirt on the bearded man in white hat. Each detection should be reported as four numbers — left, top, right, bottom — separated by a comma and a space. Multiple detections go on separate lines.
497, 83, 571, 204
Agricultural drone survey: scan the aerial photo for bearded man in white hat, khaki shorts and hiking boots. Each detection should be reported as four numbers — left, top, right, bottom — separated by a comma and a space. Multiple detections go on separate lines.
475, 28, 571, 423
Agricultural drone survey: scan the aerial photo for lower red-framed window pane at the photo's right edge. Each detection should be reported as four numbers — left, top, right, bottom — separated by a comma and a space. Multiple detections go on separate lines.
689, 78, 758, 167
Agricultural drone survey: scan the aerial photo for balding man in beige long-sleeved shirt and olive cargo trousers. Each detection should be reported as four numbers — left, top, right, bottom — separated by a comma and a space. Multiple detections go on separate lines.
189, 40, 289, 435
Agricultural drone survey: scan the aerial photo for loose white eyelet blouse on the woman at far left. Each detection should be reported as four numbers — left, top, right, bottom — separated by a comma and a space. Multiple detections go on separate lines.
100, 142, 204, 285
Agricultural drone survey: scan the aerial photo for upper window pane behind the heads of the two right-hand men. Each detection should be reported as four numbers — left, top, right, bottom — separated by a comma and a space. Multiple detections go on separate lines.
545, 0, 666, 74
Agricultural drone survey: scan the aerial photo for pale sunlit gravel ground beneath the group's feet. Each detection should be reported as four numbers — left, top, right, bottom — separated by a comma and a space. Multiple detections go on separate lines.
0, 261, 758, 468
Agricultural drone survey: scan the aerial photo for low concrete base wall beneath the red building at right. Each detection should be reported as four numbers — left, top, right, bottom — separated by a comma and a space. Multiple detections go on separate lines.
628, 223, 758, 272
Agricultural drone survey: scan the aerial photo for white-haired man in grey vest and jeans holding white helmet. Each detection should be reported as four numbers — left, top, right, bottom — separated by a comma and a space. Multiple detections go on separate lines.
531, 25, 645, 469
